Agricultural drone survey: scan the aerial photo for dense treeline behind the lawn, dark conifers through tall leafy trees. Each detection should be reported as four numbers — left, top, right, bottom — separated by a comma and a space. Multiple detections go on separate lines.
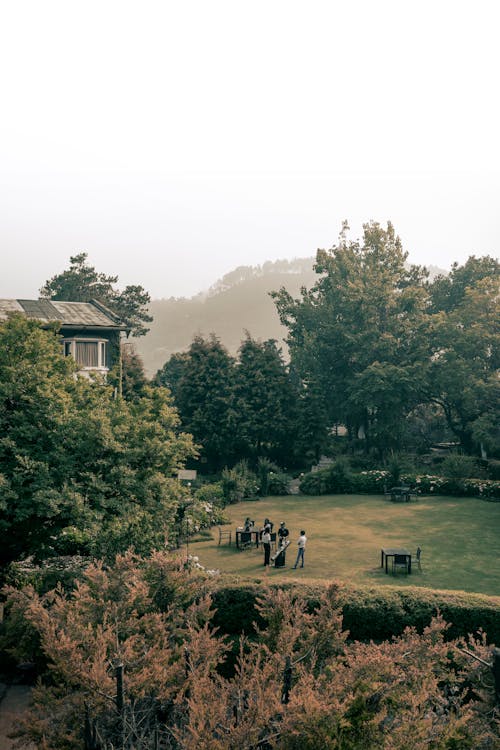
156, 223, 500, 470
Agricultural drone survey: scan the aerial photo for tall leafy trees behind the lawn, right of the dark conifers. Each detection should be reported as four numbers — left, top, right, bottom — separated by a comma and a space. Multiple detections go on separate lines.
273, 222, 500, 452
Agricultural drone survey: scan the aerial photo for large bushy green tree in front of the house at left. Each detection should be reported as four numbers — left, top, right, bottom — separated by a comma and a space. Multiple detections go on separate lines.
0, 316, 194, 562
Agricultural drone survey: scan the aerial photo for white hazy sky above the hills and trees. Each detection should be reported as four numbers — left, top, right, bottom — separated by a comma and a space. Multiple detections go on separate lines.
0, 0, 500, 298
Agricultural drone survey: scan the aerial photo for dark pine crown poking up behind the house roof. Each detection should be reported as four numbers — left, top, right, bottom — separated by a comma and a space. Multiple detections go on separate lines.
40, 253, 152, 336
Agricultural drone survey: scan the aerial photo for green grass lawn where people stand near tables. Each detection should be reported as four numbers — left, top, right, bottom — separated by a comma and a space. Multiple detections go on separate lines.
189, 495, 500, 596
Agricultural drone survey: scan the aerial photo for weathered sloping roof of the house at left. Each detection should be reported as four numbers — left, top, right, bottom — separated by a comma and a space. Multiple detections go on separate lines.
0, 299, 127, 331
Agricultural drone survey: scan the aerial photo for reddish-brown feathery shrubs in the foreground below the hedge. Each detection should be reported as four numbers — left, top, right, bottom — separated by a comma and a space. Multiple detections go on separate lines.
1, 553, 499, 750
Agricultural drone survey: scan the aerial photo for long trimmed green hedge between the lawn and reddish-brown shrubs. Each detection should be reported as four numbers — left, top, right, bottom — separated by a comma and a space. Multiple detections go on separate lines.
211, 582, 500, 644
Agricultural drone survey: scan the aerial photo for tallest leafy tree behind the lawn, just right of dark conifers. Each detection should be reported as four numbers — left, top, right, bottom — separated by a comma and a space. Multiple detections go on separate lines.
274, 222, 427, 458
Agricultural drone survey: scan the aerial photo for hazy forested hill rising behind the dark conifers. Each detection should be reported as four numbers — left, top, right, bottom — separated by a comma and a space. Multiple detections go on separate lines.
134, 257, 317, 376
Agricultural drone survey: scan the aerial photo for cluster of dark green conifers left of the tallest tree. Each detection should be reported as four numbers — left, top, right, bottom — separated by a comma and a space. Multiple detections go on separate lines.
155, 334, 296, 471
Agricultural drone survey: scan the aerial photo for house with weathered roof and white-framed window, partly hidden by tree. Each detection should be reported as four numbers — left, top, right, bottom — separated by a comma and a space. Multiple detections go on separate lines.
0, 299, 129, 377
